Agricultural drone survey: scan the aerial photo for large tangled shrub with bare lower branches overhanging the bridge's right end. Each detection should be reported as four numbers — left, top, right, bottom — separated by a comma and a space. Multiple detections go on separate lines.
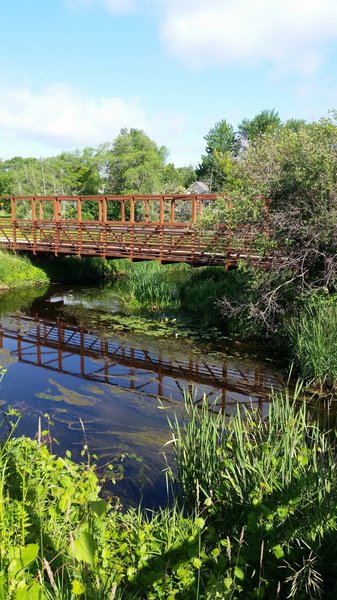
198, 119, 337, 332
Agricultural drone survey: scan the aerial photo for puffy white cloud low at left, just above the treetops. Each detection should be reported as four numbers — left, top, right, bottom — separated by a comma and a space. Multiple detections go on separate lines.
0, 83, 146, 148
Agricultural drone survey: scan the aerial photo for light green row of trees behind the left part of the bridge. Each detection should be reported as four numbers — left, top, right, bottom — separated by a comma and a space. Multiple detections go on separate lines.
0, 129, 195, 204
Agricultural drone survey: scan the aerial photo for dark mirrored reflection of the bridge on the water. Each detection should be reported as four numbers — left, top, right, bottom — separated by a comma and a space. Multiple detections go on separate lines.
0, 316, 282, 415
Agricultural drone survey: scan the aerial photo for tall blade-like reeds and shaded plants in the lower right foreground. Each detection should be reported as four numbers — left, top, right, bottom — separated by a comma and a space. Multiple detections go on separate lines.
169, 386, 337, 599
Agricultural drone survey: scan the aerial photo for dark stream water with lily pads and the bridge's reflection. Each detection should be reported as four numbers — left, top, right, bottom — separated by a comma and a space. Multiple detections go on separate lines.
0, 286, 282, 506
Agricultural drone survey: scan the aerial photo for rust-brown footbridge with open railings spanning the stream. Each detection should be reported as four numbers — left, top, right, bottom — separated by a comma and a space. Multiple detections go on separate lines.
0, 194, 273, 268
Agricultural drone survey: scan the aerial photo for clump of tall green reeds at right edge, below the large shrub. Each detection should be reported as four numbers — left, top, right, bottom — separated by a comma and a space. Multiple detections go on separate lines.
289, 296, 337, 389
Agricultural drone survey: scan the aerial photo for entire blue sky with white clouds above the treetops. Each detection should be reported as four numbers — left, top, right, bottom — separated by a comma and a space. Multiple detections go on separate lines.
0, 0, 337, 166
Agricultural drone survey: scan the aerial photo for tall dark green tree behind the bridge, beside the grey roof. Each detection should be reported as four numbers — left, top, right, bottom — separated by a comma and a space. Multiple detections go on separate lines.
196, 120, 240, 192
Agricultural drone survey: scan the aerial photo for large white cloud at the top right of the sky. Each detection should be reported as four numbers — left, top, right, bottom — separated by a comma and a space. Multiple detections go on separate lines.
156, 0, 337, 73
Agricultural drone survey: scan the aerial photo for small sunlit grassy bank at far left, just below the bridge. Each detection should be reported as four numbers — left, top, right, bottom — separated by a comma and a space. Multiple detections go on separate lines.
0, 250, 49, 289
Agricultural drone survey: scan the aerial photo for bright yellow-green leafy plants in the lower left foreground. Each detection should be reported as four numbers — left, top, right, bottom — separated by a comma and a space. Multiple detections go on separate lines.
0, 411, 204, 600
